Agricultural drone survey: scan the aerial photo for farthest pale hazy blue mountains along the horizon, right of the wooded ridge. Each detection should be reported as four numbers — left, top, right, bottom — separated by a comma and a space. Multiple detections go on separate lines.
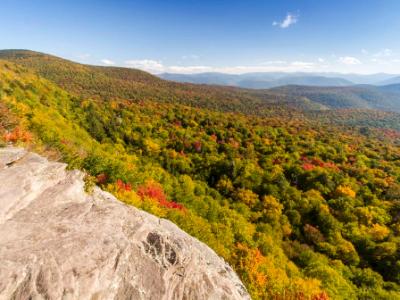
159, 72, 400, 89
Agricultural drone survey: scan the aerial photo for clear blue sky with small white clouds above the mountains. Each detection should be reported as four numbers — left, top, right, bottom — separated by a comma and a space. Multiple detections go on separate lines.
0, 0, 400, 73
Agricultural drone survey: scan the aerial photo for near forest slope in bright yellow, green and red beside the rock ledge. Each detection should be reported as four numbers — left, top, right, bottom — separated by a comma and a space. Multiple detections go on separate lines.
0, 55, 400, 299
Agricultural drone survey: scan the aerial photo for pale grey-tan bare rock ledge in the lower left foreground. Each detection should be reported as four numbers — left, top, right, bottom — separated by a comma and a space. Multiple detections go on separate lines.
0, 147, 250, 300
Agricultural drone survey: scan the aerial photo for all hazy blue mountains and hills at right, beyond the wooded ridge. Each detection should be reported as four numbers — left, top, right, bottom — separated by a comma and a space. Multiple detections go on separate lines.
159, 72, 400, 112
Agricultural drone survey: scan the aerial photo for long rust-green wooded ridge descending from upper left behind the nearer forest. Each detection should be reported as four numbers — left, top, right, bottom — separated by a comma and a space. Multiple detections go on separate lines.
0, 50, 302, 114
